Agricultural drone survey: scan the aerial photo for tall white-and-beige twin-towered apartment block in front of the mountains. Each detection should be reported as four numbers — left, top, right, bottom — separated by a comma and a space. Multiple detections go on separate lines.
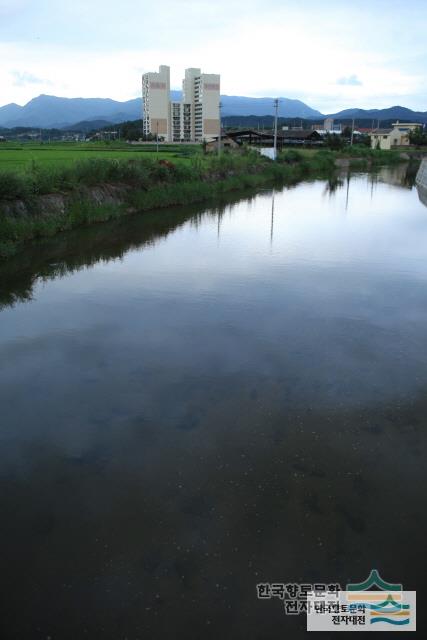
142, 66, 220, 142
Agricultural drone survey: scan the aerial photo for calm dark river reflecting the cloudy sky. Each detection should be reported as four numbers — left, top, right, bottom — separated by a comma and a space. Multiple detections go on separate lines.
0, 166, 427, 640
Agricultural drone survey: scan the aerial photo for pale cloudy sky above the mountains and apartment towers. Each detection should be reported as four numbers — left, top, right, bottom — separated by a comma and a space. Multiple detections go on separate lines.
0, 0, 427, 113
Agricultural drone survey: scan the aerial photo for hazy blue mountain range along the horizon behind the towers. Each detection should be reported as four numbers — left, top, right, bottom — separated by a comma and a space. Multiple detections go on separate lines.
0, 91, 427, 129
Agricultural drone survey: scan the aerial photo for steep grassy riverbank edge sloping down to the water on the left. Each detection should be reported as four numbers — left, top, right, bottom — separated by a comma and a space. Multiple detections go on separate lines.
0, 154, 410, 261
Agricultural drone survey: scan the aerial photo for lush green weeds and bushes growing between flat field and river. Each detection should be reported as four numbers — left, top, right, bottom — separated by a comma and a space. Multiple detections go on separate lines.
0, 149, 408, 259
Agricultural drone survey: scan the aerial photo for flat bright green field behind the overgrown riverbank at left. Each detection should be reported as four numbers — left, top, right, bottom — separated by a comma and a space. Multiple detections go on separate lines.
0, 142, 201, 173
